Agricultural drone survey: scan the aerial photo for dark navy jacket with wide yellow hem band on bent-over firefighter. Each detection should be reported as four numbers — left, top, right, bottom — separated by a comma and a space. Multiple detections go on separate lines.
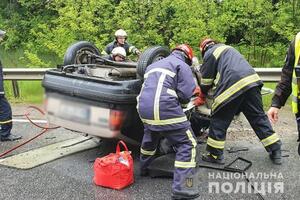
200, 44, 263, 115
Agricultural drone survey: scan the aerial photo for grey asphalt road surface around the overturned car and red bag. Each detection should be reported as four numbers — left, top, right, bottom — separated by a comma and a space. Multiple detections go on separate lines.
0, 105, 300, 200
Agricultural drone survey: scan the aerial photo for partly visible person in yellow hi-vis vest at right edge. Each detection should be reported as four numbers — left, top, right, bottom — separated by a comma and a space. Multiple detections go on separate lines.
268, 32, 300, 155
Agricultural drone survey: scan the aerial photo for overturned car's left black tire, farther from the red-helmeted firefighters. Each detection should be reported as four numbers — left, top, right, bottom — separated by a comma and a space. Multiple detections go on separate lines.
64, 41, 100, 65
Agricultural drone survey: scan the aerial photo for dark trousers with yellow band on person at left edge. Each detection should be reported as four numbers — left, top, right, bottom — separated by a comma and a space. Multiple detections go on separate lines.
0, 95, 12, 137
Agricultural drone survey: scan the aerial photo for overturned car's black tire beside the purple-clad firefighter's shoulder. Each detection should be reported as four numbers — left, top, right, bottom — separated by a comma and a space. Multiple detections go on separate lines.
136, 46, 170, 79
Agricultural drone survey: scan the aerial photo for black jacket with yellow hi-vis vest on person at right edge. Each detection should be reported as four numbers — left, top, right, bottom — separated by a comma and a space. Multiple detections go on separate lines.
272, 33, 300, 114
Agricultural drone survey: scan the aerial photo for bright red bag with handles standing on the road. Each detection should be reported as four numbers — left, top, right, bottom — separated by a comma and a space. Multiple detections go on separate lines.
93, 140, 134, 190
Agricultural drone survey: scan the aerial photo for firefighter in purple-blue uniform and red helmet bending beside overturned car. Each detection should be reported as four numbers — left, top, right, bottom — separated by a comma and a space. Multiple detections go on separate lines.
137, 44, 199, 199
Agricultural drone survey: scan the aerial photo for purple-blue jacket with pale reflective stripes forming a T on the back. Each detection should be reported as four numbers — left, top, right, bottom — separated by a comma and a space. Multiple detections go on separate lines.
137, 50, 196, 131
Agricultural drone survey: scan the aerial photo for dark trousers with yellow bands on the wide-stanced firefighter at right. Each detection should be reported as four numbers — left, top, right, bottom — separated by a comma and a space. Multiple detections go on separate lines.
206, 87, 281, 156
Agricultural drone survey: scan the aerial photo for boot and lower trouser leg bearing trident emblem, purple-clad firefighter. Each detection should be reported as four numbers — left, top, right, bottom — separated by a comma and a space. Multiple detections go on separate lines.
172, 175, 200, 199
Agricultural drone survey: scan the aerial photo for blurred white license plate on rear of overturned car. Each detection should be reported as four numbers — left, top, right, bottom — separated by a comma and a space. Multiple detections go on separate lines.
59, 104, 90, 123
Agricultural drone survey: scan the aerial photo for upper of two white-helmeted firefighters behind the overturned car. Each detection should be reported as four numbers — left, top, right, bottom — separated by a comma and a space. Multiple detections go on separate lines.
101, 29, 141, 56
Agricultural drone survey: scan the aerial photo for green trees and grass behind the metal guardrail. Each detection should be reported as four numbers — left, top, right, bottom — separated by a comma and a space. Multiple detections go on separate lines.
0, 0, 300, 106
